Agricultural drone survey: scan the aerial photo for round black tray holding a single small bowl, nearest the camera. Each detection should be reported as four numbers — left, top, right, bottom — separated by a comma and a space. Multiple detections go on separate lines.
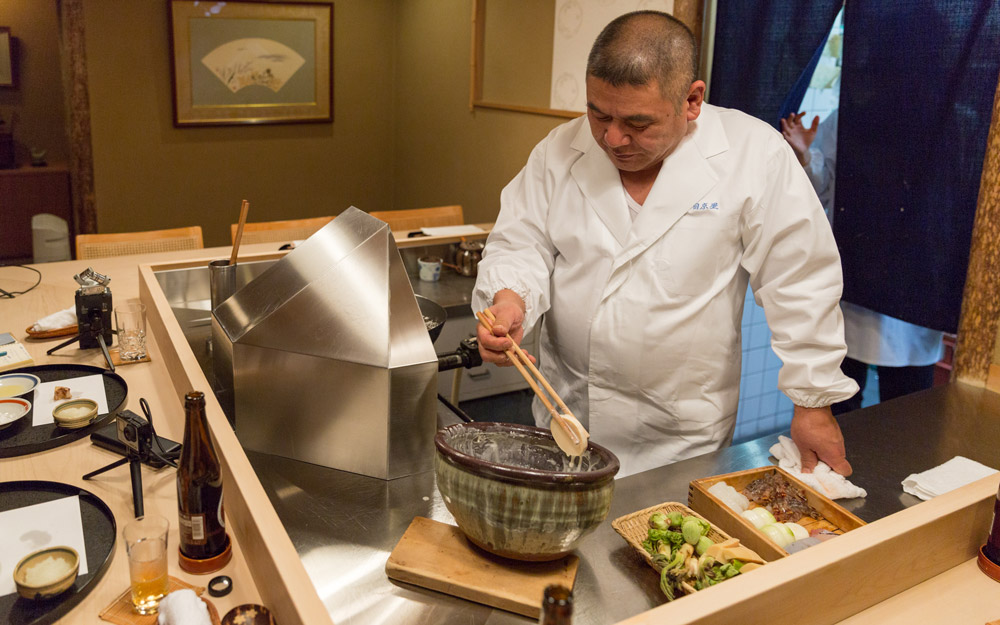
0, 482, 117, 625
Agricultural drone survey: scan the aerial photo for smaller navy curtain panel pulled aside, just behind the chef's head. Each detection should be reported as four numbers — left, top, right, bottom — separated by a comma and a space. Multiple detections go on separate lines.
711, 0, 843, 128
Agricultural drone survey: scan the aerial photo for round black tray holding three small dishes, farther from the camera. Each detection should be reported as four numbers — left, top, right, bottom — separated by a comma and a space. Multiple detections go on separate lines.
0, 365, 128, 458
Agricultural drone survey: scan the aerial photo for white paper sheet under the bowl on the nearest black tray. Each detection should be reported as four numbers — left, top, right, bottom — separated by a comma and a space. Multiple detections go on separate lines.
0, 496, 87, 597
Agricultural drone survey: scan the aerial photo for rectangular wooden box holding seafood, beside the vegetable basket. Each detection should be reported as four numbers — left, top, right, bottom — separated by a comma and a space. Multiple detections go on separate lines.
688, 466, 865, 562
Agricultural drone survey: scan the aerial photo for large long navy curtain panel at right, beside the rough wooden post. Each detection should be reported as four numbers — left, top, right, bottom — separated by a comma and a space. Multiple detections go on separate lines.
833, 0, 1000, 332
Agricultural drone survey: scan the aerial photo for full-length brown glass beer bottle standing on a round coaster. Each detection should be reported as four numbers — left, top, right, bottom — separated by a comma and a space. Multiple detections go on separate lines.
177, 391, 229, 560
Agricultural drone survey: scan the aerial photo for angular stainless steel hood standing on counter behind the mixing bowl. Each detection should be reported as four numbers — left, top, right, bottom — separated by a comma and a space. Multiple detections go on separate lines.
212, 207, 437, 479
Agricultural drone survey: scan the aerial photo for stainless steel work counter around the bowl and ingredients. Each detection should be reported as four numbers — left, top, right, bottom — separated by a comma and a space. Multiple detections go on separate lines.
247, 384, 1000, 625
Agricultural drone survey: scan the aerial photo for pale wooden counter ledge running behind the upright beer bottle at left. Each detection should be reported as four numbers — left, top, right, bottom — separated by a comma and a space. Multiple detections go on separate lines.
138, 254, 333, 625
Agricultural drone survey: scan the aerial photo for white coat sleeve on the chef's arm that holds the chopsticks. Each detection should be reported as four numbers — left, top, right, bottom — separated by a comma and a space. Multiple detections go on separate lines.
472, 141, 556, 328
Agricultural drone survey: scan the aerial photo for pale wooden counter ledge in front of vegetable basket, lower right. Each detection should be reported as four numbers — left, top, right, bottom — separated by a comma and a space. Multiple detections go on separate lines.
619, 474, 1000, 625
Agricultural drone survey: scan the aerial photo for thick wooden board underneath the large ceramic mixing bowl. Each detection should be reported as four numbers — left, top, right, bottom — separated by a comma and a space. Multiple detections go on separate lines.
385, 517, 580, 618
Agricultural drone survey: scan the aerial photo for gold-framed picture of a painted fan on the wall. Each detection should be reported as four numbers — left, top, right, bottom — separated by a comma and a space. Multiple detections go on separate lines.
170, 0, 333, 126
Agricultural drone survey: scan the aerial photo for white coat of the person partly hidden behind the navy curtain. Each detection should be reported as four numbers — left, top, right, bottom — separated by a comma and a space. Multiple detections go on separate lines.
805, 111, 944, 367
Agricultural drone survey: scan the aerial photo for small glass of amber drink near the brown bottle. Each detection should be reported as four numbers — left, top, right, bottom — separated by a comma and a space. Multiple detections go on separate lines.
122, 514, 170, 614
